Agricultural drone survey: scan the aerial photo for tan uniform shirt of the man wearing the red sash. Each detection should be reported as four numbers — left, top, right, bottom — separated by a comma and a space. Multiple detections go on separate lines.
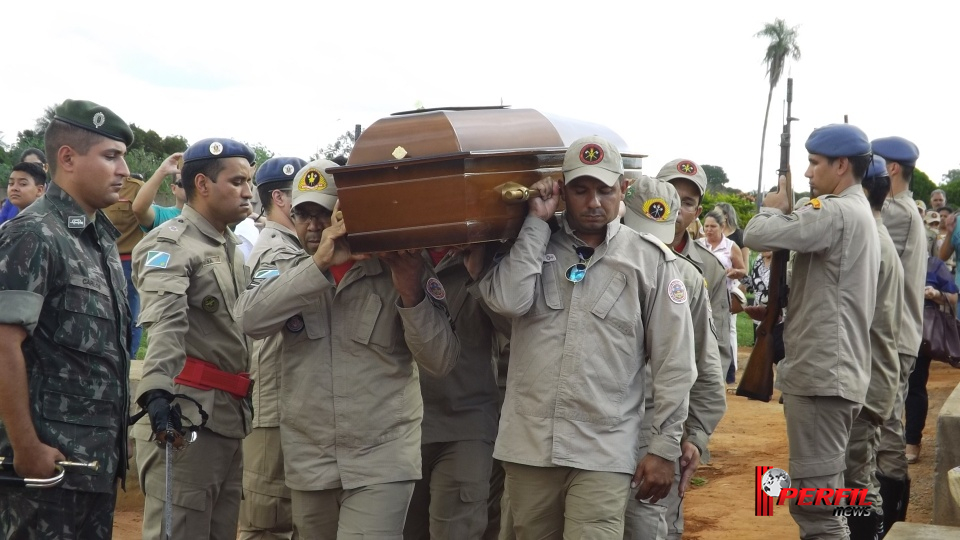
133, 205, 251, 439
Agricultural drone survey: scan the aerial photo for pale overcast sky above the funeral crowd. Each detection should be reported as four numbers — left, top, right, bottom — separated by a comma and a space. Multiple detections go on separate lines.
0, 0, 960, 191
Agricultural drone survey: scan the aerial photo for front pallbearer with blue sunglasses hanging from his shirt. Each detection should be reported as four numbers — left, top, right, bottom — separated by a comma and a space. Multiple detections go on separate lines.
477, 137, 696, 540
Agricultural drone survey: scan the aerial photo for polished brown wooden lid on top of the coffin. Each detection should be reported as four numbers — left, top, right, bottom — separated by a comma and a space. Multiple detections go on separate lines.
344, 106, 646, 176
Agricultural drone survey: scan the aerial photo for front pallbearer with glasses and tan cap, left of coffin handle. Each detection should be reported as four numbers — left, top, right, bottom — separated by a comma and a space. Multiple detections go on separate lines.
237, 160, 460, 540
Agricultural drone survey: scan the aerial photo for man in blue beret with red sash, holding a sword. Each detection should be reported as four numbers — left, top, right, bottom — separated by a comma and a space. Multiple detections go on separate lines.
133, 139, 254, 540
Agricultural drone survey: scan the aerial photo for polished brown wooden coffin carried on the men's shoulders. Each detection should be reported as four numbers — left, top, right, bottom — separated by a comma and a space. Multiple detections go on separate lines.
331, 107, 643, 253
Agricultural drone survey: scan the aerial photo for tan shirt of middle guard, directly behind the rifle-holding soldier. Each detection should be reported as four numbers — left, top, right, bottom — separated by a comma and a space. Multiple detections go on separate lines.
863, 218, 903, 425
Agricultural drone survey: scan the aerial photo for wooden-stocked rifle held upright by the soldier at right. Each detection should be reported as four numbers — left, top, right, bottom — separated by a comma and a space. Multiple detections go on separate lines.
737, 78, 796, 402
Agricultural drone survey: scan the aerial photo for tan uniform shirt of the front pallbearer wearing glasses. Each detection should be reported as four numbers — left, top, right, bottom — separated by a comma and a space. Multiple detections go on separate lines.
237, 253, 460, 491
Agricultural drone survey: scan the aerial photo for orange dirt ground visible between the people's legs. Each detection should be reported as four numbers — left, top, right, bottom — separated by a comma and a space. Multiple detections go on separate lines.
114, 348, 960, 540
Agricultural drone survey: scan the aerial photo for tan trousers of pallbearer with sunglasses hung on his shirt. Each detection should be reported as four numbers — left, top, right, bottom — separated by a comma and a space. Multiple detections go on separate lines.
500, 462, 632, 540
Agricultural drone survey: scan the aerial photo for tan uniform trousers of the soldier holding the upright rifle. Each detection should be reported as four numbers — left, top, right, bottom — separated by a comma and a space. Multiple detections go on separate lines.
783, 394, 861, 540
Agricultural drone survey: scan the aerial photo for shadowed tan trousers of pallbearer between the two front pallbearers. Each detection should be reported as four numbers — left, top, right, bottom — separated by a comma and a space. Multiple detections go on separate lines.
403, 441, 493, 540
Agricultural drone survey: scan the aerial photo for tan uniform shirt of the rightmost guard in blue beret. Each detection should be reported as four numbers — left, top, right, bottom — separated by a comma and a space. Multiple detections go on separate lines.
882, 189, 927, 356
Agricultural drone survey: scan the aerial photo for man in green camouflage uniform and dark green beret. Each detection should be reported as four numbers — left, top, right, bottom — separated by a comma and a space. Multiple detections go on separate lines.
0, 99, 133, 538
